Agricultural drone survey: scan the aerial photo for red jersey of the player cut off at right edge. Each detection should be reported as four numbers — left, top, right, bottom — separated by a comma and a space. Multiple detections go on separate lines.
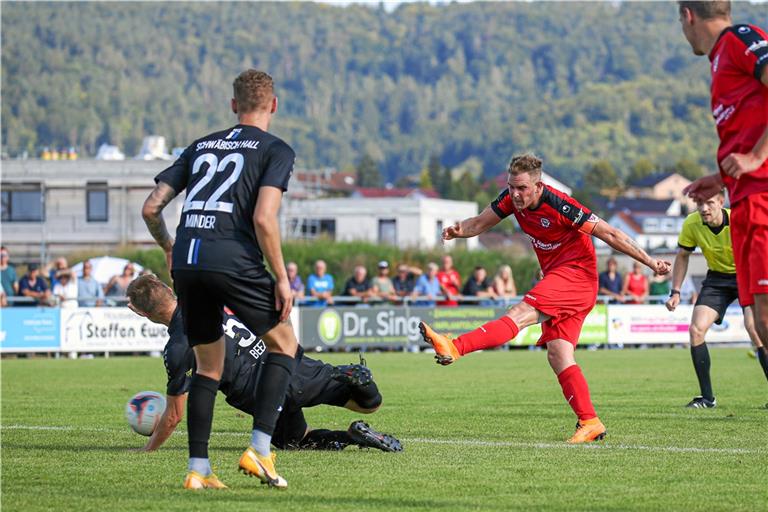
709, 25, 768, 204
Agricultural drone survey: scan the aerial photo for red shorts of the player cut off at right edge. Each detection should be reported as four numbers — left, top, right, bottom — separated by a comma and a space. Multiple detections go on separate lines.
731, 192, 768, 307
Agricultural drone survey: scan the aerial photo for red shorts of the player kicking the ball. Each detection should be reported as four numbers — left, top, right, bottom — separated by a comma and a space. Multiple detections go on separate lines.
523, 267, 597, 346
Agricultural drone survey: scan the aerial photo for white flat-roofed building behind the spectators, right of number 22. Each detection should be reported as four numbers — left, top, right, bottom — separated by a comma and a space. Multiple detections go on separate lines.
282, 193, 478, 249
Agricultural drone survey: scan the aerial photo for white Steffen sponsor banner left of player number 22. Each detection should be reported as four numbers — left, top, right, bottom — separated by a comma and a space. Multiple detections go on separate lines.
61, 308, 168, 352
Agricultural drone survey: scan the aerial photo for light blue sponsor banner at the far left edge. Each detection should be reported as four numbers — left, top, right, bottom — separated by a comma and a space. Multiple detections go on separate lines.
0, 307, 60, 352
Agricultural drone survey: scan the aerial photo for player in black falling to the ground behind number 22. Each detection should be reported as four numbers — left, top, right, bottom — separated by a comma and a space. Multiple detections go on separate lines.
127, 275, 402, 452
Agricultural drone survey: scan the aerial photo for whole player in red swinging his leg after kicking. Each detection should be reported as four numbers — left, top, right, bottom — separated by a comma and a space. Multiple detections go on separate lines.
420, 154, 670, 443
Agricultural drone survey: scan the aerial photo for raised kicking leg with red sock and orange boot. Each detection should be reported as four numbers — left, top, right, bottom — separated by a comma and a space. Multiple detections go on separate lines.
419, 302, 548, 366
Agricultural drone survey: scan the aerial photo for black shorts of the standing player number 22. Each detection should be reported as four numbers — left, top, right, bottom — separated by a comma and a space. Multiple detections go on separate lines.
173, 269, 280, 347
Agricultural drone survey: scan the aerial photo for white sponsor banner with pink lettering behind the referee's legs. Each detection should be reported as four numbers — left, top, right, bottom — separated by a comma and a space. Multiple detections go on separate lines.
608, 305, 749, 343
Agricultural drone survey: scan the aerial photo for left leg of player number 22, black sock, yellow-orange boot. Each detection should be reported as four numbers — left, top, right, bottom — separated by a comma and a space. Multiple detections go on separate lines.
184, 337, 226, 490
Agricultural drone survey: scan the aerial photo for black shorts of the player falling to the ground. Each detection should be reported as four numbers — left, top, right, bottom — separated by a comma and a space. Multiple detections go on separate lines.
272, 357, 351, 449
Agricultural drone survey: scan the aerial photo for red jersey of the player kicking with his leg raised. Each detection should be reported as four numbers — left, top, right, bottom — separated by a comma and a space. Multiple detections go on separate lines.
491, 185, 599, 281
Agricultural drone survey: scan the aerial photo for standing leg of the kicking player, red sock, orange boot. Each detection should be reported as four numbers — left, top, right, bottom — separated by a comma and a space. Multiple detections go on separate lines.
547, 340, 606, 444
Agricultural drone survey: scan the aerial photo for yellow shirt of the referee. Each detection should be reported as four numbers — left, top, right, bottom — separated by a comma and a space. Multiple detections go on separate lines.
677, 208, 736, 274
